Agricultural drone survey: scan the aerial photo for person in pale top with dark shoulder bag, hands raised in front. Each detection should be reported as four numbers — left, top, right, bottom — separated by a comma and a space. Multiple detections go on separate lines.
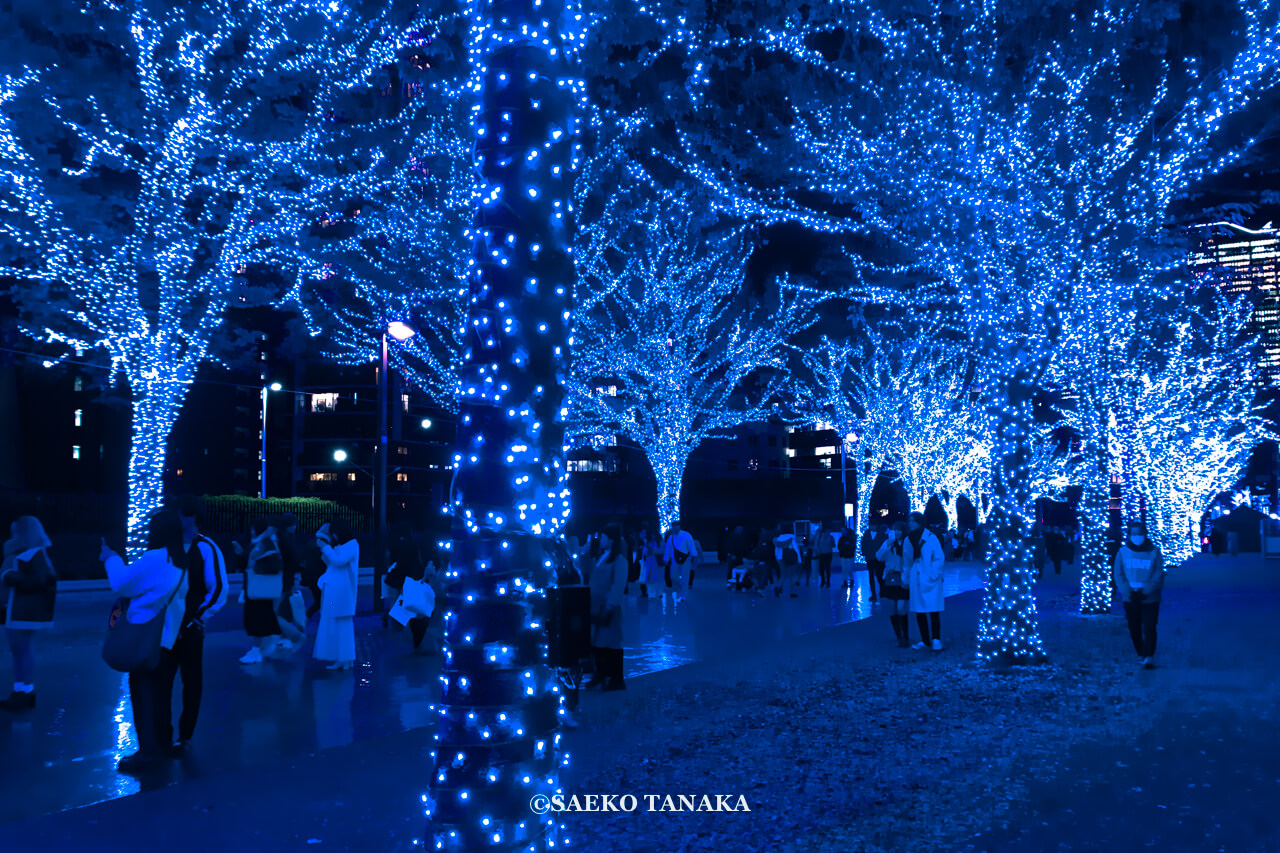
100, 511, 188, 774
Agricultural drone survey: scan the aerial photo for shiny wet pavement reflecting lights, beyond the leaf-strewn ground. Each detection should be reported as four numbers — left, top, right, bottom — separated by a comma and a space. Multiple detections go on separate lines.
0, 555, 983, 819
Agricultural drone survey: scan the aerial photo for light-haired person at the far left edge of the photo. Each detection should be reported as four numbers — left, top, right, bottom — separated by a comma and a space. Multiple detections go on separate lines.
0, 515, 58, 711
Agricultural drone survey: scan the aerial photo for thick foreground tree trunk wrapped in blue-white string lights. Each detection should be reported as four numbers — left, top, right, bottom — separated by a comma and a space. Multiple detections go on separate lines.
424, 0, 581, 850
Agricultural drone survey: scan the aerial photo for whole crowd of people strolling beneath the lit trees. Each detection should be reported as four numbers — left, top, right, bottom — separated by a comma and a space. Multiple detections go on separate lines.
0, 500, 1165, 772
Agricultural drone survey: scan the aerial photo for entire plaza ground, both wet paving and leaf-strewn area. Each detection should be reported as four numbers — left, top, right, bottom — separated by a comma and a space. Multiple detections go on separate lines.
0, 557, 1280, 853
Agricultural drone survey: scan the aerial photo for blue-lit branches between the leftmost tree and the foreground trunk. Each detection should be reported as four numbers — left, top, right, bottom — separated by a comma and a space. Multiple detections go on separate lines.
288, 12, 472, 410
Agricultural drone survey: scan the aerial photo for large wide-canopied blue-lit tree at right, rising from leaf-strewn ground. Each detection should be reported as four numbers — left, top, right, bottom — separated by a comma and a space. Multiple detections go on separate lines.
672, 0, 1280, 662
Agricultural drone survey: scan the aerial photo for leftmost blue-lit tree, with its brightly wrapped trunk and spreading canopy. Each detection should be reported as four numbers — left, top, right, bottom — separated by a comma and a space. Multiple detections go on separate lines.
0, 0, 427, 553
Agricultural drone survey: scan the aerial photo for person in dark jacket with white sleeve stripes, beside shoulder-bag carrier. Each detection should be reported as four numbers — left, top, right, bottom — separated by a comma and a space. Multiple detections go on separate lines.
165, 497, 230, 753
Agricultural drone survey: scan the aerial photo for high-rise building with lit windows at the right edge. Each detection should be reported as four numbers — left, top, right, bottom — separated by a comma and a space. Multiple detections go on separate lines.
1190, 222, 1280, 389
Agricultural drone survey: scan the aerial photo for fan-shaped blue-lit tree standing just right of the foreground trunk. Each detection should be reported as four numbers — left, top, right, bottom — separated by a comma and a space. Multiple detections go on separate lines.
572, 193, 815, 529
